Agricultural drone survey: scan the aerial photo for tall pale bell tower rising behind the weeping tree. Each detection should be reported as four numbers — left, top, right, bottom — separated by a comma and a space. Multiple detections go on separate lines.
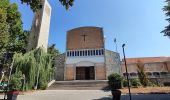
28, 0, 51, 51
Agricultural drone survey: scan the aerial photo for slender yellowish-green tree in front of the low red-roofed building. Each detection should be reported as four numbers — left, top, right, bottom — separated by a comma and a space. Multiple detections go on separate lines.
137, 61, 149, 86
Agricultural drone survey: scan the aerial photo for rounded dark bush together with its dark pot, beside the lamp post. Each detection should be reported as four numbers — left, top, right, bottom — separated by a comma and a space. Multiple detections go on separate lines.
108, 73, 122, 100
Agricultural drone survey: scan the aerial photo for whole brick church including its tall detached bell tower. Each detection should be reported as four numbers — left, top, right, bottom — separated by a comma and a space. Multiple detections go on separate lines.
27, 0, 121, 81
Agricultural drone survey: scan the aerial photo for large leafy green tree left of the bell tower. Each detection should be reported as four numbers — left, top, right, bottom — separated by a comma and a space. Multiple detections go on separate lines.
0, 0, 29, 52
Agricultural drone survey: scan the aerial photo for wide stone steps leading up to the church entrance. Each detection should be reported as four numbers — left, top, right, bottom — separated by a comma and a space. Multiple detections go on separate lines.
47, 80, 108, 90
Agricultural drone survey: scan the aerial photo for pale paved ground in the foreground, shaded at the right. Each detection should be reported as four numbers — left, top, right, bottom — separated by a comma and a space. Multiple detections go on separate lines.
0, 90, 170, 100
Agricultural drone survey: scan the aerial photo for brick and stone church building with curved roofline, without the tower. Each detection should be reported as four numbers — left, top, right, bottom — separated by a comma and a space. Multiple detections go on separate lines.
55, 27, 120, 81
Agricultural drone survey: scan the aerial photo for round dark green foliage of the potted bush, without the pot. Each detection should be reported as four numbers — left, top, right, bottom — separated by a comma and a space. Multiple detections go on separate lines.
108, 73, 122, 90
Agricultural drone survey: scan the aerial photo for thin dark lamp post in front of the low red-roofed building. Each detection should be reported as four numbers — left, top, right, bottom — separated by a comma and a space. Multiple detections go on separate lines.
122, 44, 132, 100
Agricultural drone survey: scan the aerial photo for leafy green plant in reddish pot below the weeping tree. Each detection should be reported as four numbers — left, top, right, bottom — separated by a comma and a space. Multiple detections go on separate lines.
7, 73, 22, 100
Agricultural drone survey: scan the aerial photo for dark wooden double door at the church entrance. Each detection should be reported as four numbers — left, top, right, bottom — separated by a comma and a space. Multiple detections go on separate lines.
76, 66, 95, 80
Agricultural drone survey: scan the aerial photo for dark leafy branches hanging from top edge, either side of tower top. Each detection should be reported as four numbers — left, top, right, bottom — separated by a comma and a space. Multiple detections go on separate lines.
21, 0, 74, 12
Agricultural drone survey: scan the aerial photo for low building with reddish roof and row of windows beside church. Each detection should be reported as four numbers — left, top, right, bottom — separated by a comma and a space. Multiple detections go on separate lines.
121, 57, 170, 78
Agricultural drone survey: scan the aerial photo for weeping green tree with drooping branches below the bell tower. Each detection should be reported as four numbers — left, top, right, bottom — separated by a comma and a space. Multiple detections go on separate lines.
13, 48, 53, 89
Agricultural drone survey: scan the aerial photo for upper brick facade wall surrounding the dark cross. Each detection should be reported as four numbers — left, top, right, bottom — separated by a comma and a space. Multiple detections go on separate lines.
67, 27, 104, 50
